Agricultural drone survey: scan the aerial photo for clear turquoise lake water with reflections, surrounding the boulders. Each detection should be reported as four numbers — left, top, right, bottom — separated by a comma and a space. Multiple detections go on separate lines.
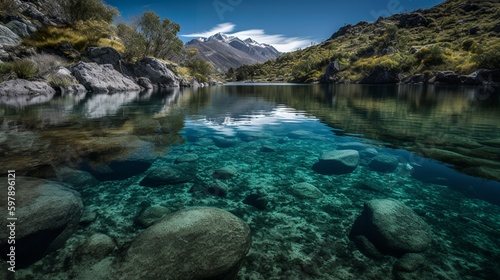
0, 84, 500, 279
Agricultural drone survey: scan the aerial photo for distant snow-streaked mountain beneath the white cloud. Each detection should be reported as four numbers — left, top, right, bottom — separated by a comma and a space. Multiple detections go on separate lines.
185, 33, 281, 72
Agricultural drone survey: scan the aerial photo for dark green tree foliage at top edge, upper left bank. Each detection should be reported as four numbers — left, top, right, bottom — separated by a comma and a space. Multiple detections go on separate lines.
60, 0, 119, 24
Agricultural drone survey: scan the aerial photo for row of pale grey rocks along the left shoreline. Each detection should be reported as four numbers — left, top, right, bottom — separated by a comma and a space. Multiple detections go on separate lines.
0, 47, 220, 97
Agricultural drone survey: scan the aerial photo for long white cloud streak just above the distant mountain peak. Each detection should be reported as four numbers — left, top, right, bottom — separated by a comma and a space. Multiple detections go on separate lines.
181, 22, 316, 52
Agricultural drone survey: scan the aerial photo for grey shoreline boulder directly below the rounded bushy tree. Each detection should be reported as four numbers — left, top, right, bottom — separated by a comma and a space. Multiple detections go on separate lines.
134, 57, 182, 87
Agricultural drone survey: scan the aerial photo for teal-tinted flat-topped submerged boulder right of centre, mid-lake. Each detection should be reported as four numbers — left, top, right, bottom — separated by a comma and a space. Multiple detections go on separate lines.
313, 150, 360, 175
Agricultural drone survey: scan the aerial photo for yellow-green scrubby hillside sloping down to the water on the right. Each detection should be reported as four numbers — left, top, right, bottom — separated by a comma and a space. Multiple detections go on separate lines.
230, 0, 500, 83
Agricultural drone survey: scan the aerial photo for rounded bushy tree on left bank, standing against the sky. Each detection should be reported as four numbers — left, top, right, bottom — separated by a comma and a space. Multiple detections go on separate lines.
136, 11, 183, 58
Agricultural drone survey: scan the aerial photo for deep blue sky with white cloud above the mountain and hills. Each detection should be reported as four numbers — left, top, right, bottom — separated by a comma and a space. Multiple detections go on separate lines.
104, 0, 444, 52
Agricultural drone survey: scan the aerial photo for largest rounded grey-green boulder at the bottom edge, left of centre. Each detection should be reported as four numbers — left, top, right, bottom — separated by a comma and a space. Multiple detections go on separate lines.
117, 208, 251, 280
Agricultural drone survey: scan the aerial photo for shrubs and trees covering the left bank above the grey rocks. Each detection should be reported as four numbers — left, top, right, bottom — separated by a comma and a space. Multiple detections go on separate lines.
0, 0, 212, 82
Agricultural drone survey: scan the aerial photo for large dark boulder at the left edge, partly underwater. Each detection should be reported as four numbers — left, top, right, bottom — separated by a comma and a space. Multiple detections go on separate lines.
0, 177, 83, 267
